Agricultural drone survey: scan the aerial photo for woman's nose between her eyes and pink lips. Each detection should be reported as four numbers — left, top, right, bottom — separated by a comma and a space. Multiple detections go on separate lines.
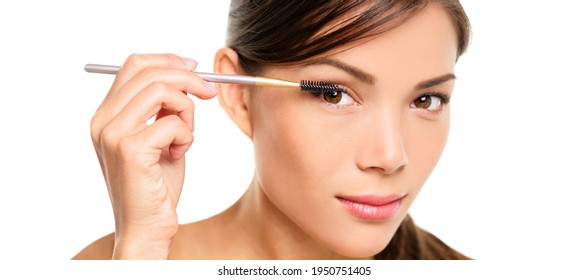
357, 111, 408, 174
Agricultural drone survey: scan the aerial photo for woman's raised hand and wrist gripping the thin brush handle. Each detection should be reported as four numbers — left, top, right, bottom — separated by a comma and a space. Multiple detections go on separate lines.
91, 54, 217, 259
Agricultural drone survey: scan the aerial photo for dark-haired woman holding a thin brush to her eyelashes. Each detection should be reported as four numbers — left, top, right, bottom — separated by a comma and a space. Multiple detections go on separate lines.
74, 0, 469, 259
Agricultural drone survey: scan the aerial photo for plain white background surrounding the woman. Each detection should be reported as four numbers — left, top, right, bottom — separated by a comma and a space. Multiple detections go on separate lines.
0, 0, 588, 278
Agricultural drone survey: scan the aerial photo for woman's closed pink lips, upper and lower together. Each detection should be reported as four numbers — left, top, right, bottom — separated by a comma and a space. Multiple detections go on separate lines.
337, 195, 402, 220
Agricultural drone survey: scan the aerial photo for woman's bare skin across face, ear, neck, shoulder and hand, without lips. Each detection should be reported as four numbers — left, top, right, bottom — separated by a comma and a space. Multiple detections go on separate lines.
74, 4, 457, 259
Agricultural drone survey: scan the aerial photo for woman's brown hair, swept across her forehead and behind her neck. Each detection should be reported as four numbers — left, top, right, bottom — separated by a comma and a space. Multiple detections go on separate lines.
227, 0, 470, 259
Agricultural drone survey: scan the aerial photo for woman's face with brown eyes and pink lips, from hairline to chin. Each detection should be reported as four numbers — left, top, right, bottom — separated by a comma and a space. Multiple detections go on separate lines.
247, 5, 457, 257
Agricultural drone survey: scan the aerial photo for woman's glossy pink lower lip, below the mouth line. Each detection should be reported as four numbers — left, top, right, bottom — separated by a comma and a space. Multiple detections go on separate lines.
337, 197, 400, 220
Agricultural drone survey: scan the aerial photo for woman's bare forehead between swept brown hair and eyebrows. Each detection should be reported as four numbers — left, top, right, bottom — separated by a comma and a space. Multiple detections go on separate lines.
327, 4, 458, 81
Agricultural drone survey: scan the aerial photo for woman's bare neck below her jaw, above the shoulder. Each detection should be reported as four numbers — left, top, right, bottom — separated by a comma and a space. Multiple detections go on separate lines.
224, 178, 356, 259
